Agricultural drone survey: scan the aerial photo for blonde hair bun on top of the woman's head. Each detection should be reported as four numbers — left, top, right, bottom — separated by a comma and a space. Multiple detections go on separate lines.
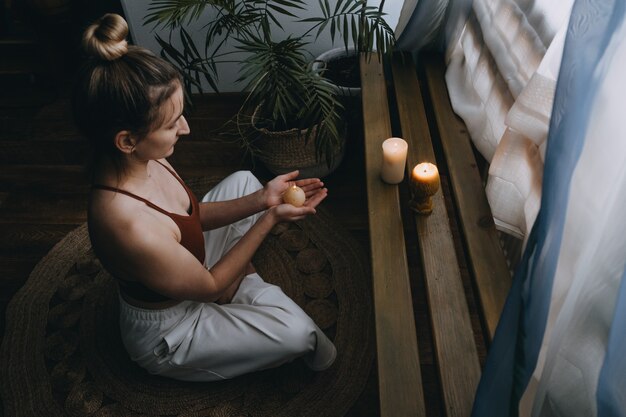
83, 13, 128, 61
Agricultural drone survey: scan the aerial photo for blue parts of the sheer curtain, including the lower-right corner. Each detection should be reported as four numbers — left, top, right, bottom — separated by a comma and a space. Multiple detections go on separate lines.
472, 0, 626, 417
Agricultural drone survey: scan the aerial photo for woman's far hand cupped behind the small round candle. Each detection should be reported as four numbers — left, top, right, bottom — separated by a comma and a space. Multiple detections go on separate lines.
263, 171, 328, 208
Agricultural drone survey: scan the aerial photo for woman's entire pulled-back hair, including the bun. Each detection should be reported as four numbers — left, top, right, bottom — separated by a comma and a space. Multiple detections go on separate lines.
72, 13, 183, 179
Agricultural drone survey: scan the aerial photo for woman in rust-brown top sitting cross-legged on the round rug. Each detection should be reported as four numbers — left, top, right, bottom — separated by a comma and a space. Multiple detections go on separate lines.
73, 14, 336, 381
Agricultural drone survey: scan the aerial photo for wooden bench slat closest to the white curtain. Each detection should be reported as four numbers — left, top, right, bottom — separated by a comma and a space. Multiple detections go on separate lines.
422, 56, 511, 340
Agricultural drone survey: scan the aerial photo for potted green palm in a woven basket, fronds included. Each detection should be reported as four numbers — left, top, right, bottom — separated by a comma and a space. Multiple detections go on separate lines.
145, 0, 392, 176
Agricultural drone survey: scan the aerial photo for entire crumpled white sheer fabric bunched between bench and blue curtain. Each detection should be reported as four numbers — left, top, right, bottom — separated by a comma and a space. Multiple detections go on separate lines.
396, 0, 573, 239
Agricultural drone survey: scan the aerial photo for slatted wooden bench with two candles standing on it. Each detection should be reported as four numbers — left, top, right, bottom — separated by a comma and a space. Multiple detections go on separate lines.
361, 55, 511, 417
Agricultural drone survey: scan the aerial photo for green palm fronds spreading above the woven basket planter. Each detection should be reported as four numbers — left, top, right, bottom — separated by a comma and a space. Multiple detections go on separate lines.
144, 0, 395, 165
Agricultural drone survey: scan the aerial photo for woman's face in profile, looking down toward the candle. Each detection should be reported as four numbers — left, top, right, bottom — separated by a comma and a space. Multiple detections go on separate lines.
134, 86, 190, 160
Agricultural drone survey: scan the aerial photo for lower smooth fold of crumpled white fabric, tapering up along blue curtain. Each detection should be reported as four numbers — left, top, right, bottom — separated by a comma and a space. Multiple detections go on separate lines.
486, 24, 567, 240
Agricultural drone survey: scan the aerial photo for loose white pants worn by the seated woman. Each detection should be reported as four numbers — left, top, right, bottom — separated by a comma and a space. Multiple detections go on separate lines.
120, 171, 336, 381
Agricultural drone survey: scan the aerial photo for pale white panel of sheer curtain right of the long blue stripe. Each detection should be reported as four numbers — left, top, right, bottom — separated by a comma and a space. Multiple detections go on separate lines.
522, 17, 626, 416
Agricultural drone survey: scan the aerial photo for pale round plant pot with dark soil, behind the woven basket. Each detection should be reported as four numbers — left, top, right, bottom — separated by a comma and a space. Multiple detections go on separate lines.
313, 47, 361, 97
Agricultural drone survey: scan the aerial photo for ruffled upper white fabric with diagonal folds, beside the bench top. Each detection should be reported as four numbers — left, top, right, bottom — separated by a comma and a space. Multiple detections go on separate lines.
446, 0, 573, 162
